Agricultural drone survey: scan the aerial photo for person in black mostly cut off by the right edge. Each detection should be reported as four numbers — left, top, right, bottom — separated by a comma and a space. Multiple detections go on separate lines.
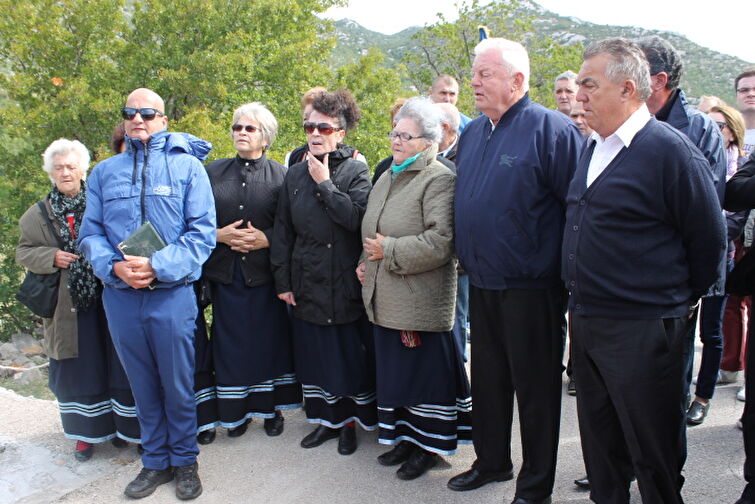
724, 152, 755, 504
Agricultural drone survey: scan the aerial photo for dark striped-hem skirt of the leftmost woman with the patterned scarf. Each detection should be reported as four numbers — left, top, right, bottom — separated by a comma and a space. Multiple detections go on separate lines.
49, 297, 140, 443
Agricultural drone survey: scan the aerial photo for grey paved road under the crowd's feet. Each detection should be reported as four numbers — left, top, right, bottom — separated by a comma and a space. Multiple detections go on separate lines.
0, 338, 744, 504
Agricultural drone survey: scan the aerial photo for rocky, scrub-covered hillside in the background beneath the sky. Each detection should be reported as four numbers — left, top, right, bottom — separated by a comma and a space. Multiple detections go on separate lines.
332, 3, 753, 103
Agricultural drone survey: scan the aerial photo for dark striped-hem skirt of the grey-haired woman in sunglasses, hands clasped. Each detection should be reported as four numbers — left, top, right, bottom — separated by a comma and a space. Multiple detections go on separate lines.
211, 263, 302, 429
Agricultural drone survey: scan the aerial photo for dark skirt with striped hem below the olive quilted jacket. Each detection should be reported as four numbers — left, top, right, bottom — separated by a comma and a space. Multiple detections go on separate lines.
374, 325, 472, 455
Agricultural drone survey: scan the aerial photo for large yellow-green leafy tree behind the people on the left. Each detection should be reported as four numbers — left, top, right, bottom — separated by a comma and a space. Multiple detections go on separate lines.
0, 0, 341, 336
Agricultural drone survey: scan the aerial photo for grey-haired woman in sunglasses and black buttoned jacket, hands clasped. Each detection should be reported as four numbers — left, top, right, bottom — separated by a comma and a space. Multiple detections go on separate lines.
203, 103, 302, 437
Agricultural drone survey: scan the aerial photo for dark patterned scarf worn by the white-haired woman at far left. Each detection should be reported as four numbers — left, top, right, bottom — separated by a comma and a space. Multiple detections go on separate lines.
50, 180, 99, 311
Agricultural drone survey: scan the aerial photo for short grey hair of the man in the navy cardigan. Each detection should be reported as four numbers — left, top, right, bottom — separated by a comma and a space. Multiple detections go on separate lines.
582, 37, 652, 102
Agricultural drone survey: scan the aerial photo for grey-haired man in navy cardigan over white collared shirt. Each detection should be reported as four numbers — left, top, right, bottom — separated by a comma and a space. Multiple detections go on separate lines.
561, 38, 726, 504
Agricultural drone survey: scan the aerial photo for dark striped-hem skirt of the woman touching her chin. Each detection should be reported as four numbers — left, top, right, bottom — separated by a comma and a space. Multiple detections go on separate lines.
292, 315, 377, 430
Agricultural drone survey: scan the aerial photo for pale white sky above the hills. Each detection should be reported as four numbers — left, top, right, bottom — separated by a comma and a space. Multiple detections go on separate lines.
326, 0, 755, 63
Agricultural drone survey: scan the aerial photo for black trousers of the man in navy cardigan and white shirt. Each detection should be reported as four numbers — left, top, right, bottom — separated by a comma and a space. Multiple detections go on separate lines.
571, 315, 688, 504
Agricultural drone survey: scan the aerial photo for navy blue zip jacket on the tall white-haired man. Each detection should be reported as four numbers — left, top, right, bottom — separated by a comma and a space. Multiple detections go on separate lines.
455, 94, 583, 290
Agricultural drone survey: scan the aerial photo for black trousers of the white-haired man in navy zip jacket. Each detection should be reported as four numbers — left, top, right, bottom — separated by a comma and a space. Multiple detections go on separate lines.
469, 286, 563, 499
